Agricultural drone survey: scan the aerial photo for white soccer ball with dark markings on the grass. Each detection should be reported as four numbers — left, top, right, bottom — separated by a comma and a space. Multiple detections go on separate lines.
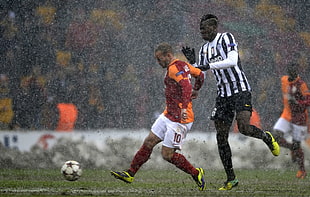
61, 160, 82, 181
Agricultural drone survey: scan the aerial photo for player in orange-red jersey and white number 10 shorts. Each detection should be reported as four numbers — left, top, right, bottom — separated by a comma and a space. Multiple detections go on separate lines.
111, 43, 206, 191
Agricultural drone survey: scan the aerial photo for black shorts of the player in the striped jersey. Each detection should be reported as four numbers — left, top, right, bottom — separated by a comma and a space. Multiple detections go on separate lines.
211, 92, 252, 124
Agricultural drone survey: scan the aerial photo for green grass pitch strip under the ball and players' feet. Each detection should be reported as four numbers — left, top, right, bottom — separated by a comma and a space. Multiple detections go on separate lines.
0, 169, 310, 197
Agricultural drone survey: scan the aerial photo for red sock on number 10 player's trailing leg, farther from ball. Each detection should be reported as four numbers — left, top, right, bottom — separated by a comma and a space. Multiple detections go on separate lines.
169, 153, 199, 176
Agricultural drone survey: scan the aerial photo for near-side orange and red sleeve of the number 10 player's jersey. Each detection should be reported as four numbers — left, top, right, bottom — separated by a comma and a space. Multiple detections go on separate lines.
169, 65, 192, 109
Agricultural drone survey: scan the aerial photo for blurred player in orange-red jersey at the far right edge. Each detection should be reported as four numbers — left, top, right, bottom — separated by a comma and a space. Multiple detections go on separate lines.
273, 64, 309, 179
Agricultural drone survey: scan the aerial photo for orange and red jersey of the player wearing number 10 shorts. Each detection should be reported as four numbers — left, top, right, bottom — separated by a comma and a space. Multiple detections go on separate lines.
164, 59, 204, 123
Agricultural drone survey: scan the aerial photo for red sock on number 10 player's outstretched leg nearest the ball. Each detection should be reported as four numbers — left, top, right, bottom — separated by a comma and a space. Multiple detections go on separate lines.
128, 144, 152, 176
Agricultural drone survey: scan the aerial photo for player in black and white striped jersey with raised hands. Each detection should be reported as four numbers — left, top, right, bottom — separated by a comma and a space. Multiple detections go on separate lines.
182, 14, 280, 190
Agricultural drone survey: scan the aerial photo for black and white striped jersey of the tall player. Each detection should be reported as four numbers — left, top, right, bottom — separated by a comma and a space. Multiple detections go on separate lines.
198, 33, 251, 97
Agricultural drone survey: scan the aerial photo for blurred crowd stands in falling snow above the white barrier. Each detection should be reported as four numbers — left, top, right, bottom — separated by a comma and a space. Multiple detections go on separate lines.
0, 0, 310, 132
